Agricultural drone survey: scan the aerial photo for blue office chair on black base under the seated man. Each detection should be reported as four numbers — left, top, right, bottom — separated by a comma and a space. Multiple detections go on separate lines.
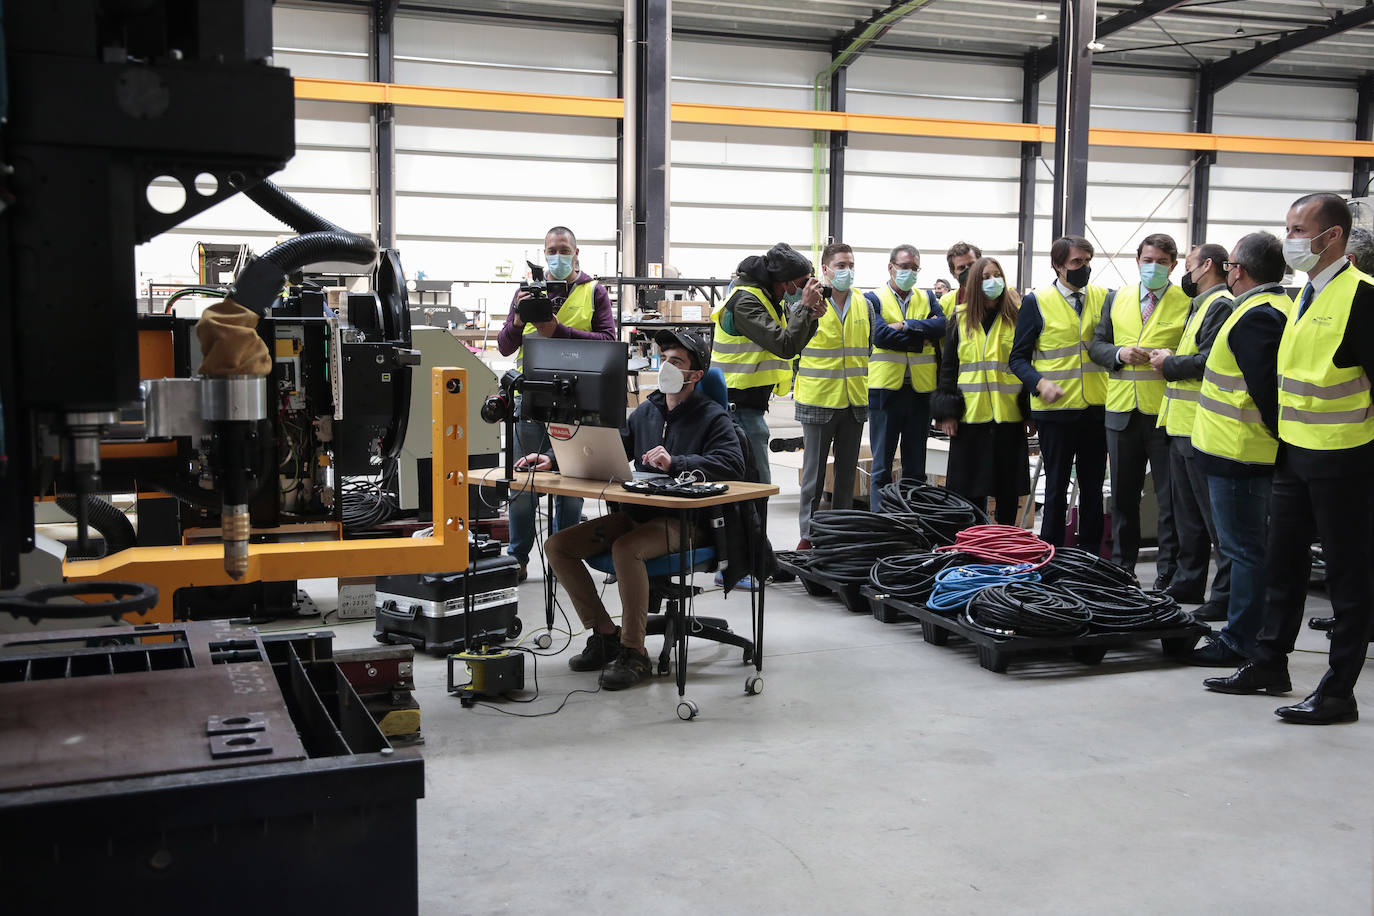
587, 367, 754, 674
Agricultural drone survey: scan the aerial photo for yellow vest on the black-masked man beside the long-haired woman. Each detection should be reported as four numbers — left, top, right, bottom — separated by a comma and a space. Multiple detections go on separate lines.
1031, 283, 1107, 411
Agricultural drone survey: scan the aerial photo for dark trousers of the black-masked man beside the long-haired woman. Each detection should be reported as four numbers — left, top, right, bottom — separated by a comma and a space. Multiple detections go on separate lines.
1036, 407, 1107, 553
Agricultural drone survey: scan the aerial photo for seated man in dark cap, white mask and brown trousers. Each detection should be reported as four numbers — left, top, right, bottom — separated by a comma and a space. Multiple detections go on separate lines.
521, 330, 745, 691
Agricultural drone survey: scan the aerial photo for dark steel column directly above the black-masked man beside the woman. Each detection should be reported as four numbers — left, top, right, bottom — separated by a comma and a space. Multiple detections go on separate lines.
1051, 0, 1098, 238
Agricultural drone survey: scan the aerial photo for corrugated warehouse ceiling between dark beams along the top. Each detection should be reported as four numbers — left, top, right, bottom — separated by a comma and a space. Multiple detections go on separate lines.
384, 0, 1374, 78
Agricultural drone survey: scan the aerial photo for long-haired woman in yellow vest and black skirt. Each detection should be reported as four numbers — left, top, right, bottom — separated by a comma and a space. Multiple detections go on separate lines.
930, 257, 1031, 525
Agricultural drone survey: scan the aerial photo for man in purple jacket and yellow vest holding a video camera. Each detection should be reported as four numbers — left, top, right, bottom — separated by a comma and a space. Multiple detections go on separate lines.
496, 225, 616, 581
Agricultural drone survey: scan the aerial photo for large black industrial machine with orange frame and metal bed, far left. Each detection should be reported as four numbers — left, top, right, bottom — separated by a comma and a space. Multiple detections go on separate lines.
0, 0, 469, 913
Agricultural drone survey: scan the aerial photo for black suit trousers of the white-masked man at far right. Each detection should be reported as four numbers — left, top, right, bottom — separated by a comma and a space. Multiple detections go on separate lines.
1254, 449, 1374, 696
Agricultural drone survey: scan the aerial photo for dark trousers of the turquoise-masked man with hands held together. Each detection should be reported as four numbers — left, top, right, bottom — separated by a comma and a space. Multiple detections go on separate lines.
1107, 411, 1179, 578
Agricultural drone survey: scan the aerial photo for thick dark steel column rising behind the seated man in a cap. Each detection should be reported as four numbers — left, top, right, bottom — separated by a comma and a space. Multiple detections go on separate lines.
625, 0, 672, 298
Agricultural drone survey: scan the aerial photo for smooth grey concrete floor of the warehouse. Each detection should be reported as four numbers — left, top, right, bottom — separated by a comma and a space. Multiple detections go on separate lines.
278, 431, 1374, 916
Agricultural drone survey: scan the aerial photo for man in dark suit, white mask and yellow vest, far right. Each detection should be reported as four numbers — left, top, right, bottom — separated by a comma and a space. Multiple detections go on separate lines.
1204, 194, 1374, 725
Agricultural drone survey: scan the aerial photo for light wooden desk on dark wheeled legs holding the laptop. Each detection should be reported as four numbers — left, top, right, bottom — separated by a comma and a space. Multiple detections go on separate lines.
470, 468, 779, 718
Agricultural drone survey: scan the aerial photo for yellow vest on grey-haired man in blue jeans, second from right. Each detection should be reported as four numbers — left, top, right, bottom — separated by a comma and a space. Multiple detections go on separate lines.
1193, 290, 1293, 464
